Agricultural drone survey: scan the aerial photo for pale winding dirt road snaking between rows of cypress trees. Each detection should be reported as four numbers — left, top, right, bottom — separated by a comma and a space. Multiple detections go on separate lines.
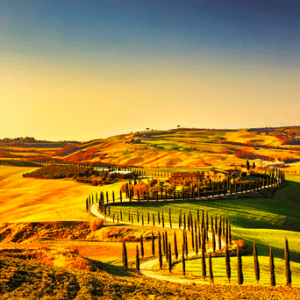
90, 204, 225, 284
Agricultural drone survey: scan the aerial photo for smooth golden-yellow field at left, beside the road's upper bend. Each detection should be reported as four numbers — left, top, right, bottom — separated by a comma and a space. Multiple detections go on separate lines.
0, 166, 122, 222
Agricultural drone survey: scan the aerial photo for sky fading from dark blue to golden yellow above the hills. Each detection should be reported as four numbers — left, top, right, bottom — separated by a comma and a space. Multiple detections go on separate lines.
0, 0, 300, 141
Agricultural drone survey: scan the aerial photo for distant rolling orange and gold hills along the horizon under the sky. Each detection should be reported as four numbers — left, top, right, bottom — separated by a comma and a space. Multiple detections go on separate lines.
0, 126, 300, 169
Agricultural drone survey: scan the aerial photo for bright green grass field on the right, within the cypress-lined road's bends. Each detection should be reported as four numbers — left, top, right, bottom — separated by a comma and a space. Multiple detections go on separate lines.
106, 175, 300, 286
